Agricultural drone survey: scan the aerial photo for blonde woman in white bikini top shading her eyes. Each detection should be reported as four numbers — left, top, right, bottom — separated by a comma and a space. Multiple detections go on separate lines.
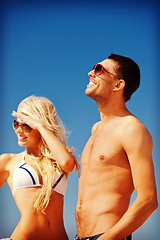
0, 96, 79, 240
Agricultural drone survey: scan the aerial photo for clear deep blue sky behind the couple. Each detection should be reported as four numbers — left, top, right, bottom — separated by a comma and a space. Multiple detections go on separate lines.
0, 0, 160, 240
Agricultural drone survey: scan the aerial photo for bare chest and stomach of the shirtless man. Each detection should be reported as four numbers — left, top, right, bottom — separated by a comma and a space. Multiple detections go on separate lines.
76, 117, 134, 237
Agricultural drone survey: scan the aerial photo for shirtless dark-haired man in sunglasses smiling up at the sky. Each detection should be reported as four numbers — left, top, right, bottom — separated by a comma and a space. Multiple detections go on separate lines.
75, 54, 158, 240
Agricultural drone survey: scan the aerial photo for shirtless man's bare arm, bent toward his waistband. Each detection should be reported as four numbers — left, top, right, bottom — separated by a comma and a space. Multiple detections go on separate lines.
98, 122, 158, 240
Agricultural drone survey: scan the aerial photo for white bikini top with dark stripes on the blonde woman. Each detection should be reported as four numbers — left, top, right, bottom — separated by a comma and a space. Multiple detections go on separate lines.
12, 154, 67, 195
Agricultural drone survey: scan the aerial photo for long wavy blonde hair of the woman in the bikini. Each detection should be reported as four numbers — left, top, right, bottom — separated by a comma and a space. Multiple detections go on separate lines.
18, 96, 80, 213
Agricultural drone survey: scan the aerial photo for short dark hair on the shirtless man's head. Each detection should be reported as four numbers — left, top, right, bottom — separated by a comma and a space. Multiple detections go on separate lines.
108, 53, 140, 102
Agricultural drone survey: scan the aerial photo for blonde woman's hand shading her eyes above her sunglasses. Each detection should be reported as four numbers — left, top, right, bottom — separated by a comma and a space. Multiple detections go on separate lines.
12, 111, 42, 130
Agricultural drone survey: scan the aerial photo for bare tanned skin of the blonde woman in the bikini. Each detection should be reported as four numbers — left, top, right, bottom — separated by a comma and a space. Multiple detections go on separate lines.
0, 112, 75, 240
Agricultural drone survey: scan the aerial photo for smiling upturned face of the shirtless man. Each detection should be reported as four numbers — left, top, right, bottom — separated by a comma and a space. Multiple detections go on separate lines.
85, 59, 117, 101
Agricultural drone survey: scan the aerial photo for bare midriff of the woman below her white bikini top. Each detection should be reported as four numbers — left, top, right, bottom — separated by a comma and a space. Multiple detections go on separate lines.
11, 188, 68, 240
